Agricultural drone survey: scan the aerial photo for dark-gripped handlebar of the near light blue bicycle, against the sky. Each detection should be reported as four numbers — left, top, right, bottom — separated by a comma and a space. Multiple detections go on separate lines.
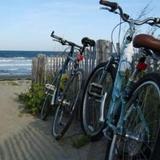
100, 0, 160, 27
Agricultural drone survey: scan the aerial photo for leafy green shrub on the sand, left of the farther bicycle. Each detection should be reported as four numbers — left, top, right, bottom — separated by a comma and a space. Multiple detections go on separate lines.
18, 83, 45, 115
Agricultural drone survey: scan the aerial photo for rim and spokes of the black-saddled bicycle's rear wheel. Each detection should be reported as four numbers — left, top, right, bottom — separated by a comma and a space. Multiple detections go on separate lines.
52, 71, 83, 139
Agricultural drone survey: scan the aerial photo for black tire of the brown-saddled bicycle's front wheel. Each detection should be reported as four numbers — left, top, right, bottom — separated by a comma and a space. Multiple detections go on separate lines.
81, 62, 115, 141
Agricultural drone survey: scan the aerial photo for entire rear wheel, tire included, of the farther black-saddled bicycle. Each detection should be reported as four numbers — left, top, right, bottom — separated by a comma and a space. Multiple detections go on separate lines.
52, 69, 83, 140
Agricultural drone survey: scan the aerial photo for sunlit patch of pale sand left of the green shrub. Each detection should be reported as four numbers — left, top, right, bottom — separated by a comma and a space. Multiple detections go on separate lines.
0, 80, 32, 139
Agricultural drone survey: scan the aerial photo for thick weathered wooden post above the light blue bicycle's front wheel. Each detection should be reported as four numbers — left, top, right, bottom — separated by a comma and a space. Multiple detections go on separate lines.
96, 40, 112, 65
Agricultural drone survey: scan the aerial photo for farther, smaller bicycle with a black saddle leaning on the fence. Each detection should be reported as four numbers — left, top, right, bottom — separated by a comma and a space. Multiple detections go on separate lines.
41, 31, 95, 140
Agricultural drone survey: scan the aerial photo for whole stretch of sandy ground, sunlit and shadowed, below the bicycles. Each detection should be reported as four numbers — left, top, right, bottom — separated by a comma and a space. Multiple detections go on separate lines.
0, 81, 105, 160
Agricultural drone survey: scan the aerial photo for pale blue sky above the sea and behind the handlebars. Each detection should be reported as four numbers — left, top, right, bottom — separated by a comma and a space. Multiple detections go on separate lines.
0, 0, 160, 51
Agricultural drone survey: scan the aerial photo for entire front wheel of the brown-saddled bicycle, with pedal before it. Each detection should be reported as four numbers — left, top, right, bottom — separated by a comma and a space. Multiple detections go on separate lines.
81, 63, 115, 140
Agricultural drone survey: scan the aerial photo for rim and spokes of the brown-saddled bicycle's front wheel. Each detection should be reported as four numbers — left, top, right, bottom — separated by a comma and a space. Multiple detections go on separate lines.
82, 66, 113, 137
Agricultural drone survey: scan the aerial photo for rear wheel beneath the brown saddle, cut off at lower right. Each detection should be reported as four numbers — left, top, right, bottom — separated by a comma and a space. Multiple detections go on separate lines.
107, 73, 160, 160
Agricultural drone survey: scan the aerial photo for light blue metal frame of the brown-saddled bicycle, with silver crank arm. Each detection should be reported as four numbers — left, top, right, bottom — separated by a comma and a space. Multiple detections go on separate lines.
100, 20, 147, 135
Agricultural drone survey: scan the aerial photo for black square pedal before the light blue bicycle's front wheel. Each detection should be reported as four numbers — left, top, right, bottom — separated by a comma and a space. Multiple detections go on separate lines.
88, 83, 103, 98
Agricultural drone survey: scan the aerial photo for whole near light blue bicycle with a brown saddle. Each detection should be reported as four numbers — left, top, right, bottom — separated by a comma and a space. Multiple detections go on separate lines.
81, 0, 160, 160
